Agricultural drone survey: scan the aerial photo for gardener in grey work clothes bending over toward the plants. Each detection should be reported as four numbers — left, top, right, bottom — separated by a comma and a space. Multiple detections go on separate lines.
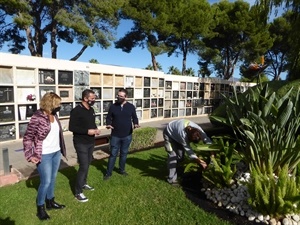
163, 119, 212, 185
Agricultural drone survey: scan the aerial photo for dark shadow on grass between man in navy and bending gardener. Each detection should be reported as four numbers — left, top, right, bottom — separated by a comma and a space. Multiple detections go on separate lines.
126, 154, 167, 180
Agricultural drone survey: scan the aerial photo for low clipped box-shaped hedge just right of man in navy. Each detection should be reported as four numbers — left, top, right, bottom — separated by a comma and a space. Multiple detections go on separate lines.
129, 127, 157, 151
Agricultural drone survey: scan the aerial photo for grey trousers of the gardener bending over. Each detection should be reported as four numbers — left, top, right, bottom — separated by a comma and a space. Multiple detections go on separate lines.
163, 130, 185, 184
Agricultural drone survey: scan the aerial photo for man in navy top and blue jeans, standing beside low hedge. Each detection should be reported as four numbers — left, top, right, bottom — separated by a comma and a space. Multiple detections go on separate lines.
104, 88, 139, 180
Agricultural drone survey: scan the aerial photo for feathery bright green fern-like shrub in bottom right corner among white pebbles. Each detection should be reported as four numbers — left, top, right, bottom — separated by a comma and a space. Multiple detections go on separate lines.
247, 164, 300, 219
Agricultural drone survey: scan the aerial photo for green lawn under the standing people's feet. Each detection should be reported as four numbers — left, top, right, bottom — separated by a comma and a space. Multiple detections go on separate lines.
0, 148, 230, 225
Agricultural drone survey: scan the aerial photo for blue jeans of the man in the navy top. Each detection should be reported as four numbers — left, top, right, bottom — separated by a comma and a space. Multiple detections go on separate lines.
106, 135, 132, 176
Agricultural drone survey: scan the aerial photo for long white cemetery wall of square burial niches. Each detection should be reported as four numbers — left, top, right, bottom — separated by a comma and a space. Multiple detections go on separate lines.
0, 53, 255, 142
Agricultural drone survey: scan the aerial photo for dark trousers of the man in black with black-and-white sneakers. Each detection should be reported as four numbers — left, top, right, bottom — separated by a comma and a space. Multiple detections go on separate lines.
73, 141, 95, 194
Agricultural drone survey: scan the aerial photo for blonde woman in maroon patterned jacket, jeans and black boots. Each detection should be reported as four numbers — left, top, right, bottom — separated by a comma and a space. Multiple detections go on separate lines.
23, 92, 66, 220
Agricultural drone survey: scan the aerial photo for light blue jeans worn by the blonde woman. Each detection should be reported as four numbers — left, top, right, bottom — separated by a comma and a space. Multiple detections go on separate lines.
36, 150, 61, 205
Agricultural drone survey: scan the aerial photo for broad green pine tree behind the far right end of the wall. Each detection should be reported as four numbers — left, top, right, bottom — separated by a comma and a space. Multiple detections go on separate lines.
198, 1, 272, 79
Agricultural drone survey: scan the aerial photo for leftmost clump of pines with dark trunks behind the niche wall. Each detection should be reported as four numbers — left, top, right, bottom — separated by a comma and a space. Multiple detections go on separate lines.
0, 0, 124, 60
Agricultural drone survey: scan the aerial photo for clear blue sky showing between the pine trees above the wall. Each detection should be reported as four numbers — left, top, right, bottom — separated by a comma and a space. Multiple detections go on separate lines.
1, 18, 199, 73
